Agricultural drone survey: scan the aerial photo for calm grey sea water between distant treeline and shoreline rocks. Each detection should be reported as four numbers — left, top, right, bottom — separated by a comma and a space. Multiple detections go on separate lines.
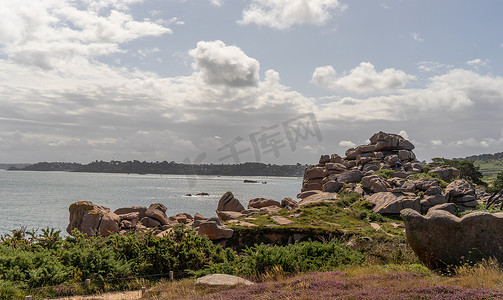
0, 170, 302, 234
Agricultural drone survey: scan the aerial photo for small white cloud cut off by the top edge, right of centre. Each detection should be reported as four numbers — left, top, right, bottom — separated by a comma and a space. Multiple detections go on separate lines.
238, 0, 347, 30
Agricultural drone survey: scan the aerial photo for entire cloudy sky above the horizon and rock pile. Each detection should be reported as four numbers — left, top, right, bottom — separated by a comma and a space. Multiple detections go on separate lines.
0, 0, 503, 163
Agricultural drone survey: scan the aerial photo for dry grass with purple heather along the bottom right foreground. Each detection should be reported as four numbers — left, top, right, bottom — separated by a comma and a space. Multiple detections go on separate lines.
145, 262, 503, 299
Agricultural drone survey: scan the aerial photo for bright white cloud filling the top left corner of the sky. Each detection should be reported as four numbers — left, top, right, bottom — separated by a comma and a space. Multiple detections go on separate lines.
0, 0, 171, 69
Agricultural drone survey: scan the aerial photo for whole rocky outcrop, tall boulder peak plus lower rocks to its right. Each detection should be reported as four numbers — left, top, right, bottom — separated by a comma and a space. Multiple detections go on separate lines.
297, 132, 477, 214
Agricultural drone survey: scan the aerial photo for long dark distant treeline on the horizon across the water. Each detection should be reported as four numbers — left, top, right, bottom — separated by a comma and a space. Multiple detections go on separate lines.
9, 160, 307, 177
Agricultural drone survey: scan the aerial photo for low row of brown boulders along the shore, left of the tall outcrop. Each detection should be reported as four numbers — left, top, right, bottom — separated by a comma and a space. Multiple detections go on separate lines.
66, 192, 299, 241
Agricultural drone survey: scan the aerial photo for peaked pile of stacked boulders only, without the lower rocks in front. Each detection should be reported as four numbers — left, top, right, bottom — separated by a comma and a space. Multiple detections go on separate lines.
298, 131, 422, 198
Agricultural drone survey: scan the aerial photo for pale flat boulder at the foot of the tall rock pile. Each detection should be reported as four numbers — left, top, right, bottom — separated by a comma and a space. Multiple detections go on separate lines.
365, 192, 421, 214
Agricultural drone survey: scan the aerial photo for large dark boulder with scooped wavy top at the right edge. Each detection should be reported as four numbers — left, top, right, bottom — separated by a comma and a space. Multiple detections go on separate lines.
401, 209, 503, 269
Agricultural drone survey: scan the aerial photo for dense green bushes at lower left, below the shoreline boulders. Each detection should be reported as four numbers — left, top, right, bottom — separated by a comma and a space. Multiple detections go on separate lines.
0, 228, 230, 299
